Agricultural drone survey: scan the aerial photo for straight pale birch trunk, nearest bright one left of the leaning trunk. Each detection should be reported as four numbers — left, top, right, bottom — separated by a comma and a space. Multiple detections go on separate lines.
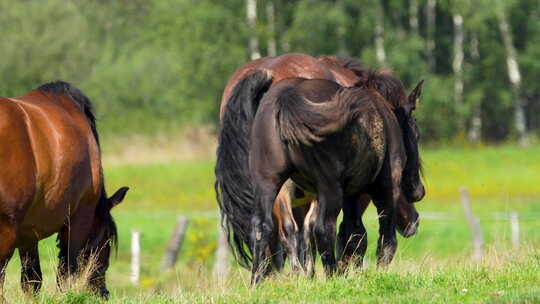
452, 14, 465, 130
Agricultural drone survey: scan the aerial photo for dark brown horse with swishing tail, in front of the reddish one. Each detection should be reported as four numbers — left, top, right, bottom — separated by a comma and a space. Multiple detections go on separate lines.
249, 72, 424, 285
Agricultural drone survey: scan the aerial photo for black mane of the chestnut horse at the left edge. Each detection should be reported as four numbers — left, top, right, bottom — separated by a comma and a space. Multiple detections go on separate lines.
36, 80, 118, 249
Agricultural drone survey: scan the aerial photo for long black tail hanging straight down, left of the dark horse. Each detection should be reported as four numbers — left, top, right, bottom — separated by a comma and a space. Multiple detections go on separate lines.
215, 72, 272, 267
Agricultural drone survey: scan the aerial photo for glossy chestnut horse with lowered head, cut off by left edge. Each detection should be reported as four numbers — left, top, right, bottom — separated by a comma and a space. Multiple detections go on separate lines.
0, 81, 128, 298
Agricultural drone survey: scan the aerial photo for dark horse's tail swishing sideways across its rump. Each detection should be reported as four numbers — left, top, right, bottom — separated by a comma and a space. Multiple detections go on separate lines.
276, 87, 366, 146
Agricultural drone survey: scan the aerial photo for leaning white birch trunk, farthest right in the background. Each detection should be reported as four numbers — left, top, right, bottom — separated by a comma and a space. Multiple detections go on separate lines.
497, 3, 529, 146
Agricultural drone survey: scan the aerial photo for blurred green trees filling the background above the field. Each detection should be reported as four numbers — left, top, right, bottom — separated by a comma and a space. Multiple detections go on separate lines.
0, 0, 540, 143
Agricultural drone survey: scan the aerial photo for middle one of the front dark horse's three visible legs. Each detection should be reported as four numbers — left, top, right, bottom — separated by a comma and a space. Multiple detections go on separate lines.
314, 181, 343, 276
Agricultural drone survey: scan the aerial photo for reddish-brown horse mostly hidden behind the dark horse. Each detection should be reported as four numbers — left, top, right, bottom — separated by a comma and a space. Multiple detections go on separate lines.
215, 54, 418, 268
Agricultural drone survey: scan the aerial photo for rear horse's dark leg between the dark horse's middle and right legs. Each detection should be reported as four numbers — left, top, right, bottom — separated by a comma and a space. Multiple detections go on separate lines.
337, 195, 371, 270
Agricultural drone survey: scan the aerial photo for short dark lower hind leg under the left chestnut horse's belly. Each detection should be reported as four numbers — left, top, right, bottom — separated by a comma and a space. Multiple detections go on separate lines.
19, 242, 43, 294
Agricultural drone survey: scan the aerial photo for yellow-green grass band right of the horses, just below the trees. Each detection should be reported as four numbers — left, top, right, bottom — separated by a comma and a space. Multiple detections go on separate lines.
422, 145, 540, 200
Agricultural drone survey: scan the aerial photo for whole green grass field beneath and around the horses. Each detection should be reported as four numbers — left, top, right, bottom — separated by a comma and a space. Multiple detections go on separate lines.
2, 145, 540, 303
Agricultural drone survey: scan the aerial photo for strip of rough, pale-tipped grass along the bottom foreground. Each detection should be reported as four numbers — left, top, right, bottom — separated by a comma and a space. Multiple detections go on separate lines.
8, 246, 540, 303
